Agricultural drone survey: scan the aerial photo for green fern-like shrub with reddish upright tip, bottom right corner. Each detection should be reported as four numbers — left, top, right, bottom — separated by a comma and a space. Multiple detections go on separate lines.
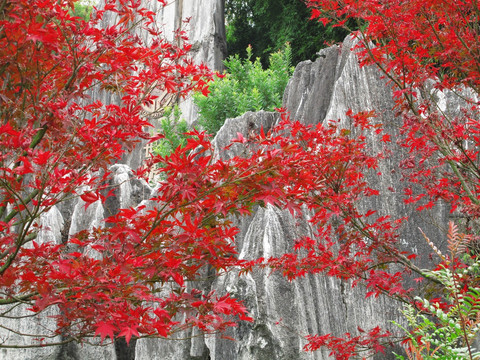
394, 223, 480, 360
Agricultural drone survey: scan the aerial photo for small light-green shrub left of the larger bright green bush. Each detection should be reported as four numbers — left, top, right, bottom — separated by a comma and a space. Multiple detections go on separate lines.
153, 106, 189, 160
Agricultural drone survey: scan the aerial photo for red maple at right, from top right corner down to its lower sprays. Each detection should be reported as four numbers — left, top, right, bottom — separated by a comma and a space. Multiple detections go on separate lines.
278, 0, 480, 359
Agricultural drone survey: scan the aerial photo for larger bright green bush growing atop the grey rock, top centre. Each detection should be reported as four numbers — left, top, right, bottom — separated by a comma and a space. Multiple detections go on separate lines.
194, 44, 293, 134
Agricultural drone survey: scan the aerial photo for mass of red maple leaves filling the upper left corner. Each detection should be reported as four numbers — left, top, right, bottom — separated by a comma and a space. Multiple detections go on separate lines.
0, 1, 210, 222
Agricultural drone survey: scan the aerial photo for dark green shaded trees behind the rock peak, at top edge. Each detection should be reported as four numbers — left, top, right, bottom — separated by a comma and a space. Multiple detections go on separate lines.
225, 0, 347, 66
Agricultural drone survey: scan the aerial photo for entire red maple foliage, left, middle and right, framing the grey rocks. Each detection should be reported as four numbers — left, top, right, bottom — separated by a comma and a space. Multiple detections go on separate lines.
0, 0, 480, 359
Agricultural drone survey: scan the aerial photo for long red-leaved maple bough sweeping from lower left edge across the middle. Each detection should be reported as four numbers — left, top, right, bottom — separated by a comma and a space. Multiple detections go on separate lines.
1, 55, 402, 341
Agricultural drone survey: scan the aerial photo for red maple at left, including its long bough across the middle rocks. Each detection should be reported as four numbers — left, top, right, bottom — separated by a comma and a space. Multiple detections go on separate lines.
0, 0, 376, 347
